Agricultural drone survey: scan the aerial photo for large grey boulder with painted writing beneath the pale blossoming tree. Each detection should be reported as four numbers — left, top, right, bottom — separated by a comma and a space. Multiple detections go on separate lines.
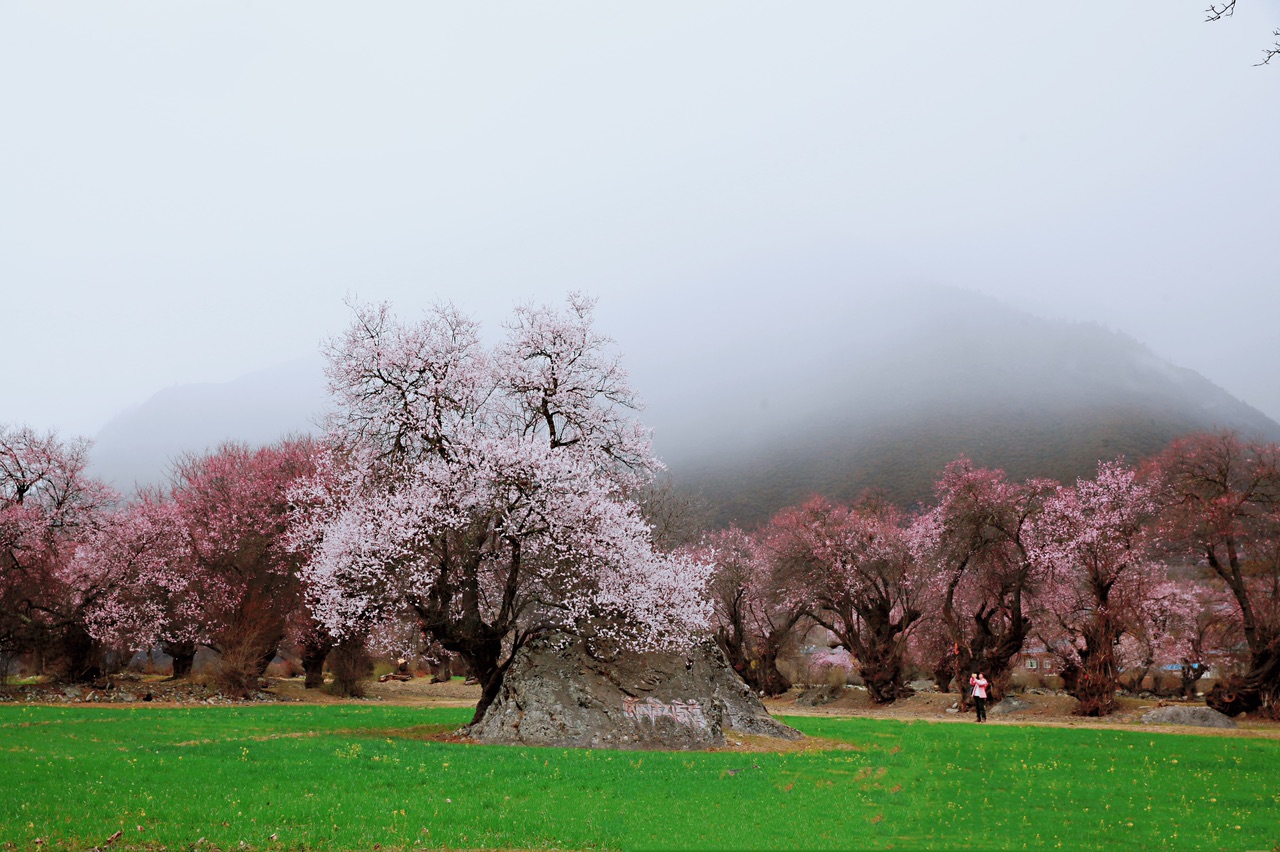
467, 633, 803, 750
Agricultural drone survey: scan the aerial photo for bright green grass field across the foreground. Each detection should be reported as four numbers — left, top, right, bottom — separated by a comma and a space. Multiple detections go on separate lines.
0, 705, 1280, 849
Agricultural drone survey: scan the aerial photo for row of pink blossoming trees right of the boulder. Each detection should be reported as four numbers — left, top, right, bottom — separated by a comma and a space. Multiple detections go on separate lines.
695, 434, 1280, 715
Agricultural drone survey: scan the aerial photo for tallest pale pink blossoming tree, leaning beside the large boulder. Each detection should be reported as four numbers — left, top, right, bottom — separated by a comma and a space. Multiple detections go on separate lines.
294, 296, 709, 719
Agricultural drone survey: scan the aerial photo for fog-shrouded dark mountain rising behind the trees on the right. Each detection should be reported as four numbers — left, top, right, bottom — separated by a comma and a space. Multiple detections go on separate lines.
646, 288, 1280, 525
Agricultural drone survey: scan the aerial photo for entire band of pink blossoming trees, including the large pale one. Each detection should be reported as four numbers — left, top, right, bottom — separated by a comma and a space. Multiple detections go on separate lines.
0, 296, 1280, 719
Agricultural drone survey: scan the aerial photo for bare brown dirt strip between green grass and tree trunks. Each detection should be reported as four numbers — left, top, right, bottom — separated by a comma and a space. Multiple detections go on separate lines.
0, 674, 1280, 751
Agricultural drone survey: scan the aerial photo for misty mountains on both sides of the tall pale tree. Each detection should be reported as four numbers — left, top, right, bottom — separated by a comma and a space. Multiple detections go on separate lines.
92, 289, 1280, 525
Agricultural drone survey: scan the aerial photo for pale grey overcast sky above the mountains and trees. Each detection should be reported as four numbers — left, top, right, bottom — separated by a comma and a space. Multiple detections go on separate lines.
0, 0, 1280, 435
